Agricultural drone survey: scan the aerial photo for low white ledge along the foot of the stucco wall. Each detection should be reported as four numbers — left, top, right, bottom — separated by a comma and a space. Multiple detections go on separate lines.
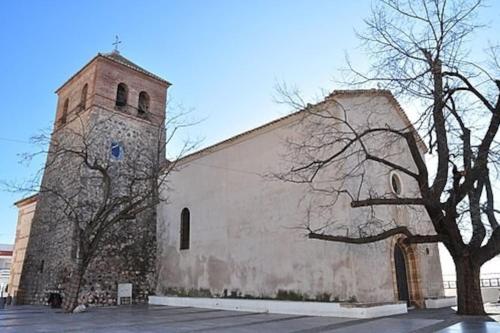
149, 296, 408, 318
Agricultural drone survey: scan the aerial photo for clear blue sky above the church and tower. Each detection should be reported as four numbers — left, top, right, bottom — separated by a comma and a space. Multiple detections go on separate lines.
0, 0, 500, 274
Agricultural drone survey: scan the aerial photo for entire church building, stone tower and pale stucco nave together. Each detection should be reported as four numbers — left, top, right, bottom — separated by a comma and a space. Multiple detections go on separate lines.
9, 54, 443, 306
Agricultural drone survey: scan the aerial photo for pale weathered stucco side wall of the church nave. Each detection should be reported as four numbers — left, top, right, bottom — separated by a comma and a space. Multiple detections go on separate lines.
157, 92, 442, 302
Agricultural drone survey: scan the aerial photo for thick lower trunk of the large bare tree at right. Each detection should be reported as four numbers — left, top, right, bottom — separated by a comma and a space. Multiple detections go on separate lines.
454, 256, 485, 315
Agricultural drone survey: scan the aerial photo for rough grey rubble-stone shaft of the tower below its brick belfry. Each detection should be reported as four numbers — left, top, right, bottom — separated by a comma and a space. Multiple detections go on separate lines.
20, 108, 158, 305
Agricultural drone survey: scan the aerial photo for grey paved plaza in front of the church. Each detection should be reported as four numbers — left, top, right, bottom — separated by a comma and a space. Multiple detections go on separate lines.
0, 305, 500, 333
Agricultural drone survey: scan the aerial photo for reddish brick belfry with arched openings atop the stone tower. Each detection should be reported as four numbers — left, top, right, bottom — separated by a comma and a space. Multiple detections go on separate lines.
54, 51, 170, 129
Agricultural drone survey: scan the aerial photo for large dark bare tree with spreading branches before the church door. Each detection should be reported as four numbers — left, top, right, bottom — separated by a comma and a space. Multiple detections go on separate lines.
279, 0, 500, 315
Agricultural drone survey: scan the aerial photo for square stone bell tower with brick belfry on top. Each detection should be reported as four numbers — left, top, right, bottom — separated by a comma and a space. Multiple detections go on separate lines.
16, 50, 170, 304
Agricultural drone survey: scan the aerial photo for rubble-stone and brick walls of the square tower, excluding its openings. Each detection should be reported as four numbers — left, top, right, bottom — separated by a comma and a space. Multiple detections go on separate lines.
18, 58, 166, 305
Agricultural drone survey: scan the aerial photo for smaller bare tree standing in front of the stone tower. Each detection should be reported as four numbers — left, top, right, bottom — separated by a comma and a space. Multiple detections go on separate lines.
8, 111, 196, 312
